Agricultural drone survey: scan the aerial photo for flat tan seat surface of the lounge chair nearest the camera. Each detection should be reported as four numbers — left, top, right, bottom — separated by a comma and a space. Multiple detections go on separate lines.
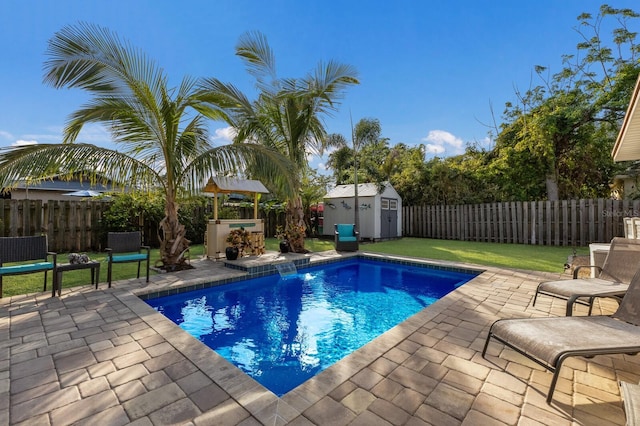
491, 316, 640, 365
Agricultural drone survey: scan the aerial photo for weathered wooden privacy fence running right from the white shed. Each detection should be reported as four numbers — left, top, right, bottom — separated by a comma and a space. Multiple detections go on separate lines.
402, 198, 640, 246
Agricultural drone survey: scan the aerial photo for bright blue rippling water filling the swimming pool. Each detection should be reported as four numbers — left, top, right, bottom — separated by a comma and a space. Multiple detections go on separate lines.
146, 259, 475, 396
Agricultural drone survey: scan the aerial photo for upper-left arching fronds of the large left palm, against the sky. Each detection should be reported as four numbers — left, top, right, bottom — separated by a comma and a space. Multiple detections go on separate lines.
44, 24, 167, 148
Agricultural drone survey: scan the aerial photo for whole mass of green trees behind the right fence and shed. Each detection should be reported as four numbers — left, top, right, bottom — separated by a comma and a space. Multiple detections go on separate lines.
348, 5, 640, 205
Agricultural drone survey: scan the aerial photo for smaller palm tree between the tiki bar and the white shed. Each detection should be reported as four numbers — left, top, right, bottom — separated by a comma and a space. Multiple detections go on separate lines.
201, 32, 359, 252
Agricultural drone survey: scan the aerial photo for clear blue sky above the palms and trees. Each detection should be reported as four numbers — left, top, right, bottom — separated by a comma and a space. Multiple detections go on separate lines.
0, 0, 640, 172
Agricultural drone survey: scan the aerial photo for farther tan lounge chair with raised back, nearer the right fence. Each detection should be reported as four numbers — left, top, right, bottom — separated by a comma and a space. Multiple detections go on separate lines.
533, 237, 640, 316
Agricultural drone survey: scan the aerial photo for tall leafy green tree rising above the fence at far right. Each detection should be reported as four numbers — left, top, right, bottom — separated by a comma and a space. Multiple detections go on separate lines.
496, 5, 640, 200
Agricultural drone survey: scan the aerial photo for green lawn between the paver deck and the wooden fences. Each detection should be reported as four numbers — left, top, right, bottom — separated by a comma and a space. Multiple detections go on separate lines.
3, 238, 589, 296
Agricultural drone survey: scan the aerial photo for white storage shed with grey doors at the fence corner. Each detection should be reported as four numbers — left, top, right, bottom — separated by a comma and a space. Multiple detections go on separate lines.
322, 182, 402, 241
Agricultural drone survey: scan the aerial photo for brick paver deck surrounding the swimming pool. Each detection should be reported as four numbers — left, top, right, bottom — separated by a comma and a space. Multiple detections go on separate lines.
0, 254, 640, 426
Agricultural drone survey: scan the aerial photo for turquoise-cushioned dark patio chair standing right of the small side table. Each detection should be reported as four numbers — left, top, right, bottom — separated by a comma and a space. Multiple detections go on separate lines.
105, 231, 151, 287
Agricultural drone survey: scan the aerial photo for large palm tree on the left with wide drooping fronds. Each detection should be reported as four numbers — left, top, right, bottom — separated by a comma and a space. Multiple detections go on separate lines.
0, 24, 292, 268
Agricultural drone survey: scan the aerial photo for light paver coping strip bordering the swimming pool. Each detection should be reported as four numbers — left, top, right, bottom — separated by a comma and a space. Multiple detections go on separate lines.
120, 252, 491, 424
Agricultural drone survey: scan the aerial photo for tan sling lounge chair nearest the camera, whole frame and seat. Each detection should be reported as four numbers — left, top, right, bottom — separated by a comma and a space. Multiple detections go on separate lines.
482, 270, 640, 404
